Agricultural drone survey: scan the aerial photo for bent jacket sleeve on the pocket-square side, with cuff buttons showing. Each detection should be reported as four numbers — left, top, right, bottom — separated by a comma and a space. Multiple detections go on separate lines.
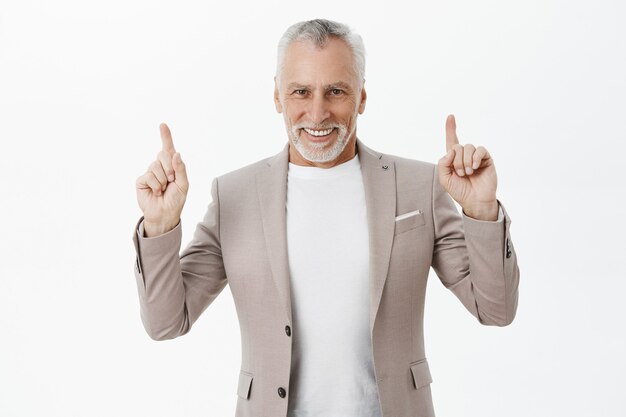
432, 166, 519, 326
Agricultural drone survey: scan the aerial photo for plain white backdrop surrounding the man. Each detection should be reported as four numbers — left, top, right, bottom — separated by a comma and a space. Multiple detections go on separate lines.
0, 0, 626, 417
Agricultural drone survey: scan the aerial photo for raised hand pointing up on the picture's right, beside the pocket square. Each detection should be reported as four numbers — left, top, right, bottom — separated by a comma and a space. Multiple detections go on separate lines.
438, 115, 498, 221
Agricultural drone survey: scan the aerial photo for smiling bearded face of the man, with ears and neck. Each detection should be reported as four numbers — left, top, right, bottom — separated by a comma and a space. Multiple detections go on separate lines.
274, 38, 367, 168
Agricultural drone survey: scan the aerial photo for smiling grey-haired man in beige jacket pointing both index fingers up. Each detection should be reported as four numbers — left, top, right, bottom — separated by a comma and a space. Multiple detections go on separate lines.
133, 19, 519, 417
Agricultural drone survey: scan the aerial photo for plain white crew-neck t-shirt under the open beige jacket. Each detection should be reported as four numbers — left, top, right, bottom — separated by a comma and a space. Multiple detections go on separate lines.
287, 155, 381, 417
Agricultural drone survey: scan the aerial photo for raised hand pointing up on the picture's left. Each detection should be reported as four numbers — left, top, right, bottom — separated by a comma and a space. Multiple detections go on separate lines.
136, 123, 189, 237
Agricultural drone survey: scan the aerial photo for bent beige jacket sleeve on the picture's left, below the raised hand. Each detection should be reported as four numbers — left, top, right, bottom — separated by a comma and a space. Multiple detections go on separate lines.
133, 178, 227, 340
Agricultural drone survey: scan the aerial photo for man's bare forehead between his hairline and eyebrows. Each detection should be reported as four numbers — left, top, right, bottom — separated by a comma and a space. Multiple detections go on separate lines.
282, 38, 356, 85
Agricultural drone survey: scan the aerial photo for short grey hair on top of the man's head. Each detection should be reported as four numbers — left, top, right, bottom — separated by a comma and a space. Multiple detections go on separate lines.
276, 19, 365, 87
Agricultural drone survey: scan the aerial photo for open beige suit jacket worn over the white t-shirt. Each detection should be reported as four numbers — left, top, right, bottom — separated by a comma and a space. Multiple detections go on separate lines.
132, 139, 519, 417
